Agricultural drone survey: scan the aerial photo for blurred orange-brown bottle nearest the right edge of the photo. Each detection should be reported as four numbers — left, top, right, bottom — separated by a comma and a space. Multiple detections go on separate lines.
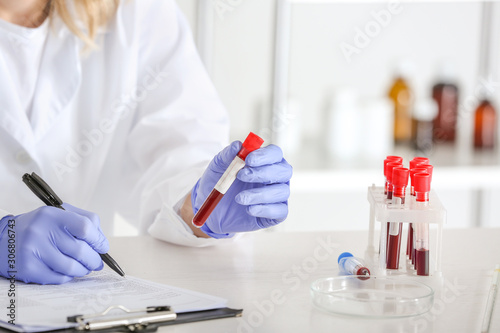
474, 99, 497, 149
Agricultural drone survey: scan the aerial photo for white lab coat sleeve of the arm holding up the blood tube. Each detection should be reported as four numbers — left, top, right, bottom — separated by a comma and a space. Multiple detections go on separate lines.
119, 0, 229, 246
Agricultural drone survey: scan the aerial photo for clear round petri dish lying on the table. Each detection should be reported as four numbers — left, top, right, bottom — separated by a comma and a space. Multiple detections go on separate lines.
311, 275, 434, 318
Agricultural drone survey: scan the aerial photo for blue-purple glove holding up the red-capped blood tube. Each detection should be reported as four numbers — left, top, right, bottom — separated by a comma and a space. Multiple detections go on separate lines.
191, 141, 292, 238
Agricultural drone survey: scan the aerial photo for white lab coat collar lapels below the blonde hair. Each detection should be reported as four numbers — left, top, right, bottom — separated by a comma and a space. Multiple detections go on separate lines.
0, 17, 82, 151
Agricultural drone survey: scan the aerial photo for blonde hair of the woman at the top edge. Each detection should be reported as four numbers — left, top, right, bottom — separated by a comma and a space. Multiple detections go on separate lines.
49, 0, 120, 47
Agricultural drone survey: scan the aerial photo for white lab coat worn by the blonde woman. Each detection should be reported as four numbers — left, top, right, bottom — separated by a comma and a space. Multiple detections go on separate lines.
0, 0, 228, 246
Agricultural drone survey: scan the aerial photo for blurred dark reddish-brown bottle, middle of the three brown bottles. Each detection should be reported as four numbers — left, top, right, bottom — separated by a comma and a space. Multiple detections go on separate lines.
432, 83, 458, 142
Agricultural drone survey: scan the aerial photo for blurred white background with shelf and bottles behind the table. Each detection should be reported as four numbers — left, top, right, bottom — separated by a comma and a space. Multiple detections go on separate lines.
177, 0, 500, 231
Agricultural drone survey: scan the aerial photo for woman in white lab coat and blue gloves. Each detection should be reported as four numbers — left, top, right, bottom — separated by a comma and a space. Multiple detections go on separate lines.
0, 0, 292, 284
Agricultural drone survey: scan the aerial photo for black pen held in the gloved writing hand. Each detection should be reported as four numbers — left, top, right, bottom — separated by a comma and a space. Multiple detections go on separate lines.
23, 172, 125, 276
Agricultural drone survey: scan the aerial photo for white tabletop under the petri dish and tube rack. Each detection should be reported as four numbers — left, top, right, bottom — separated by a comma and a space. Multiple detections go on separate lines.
110, 228, 500, 333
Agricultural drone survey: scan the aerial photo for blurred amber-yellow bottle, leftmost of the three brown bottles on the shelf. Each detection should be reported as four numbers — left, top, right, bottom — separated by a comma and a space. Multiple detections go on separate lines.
389, 77, 413, 143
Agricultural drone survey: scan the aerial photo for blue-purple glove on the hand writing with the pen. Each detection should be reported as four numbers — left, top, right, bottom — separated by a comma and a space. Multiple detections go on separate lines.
0, 204, 109, 284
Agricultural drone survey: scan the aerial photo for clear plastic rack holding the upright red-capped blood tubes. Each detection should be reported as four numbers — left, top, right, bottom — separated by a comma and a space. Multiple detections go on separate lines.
365, 185, 446, 279
